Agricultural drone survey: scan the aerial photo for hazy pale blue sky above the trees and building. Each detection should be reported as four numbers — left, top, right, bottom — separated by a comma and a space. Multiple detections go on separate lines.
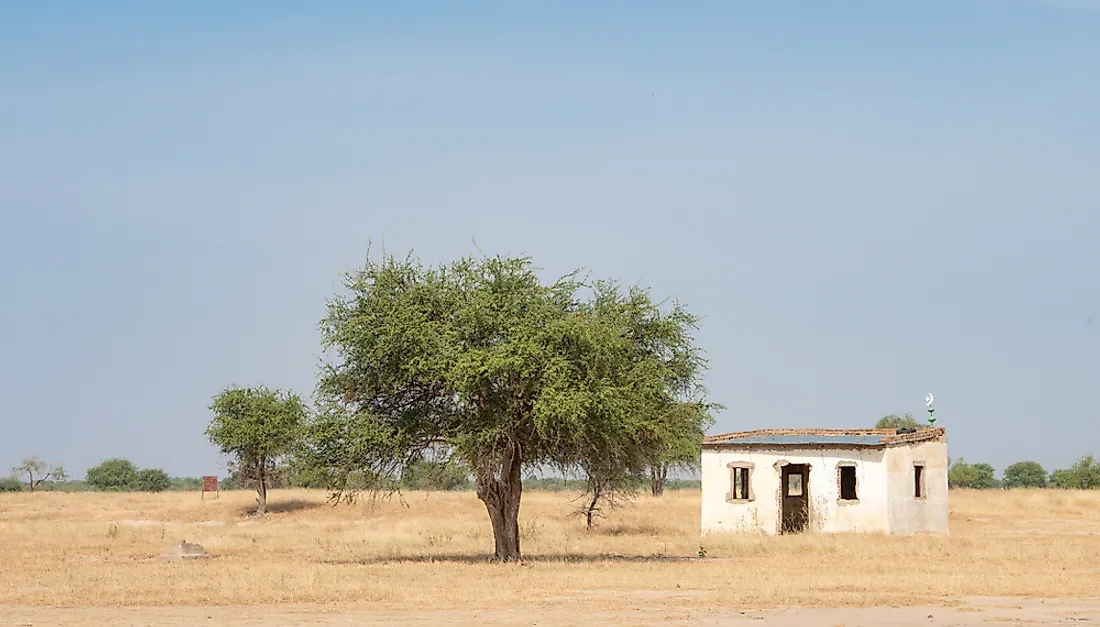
0, 0, 1100, 476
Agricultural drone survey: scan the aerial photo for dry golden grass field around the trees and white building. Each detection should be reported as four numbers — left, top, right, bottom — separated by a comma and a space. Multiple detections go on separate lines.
0, 491, 1100, 609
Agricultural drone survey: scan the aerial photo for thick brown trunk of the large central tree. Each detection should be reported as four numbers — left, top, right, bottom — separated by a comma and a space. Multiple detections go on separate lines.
476, 442, 524, 562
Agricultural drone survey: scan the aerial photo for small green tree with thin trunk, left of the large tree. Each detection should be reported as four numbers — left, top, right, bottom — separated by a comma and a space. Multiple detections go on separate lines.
207, 386, 307, 516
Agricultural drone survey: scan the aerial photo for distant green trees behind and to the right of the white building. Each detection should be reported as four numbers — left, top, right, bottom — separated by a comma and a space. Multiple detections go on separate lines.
875, 414, 1100, 490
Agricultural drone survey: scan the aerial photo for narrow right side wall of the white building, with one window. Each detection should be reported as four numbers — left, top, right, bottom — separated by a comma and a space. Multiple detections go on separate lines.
886, 441, 948, 535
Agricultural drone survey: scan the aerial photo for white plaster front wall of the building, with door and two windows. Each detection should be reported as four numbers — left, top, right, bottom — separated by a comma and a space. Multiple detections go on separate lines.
701, 447, 893, 535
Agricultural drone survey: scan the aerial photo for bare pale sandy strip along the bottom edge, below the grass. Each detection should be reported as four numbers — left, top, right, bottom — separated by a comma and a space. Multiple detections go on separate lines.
8, 598, 1100, 627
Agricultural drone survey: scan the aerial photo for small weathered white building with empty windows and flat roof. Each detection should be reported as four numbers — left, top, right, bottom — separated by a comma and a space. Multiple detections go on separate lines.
702, 427, 948, 535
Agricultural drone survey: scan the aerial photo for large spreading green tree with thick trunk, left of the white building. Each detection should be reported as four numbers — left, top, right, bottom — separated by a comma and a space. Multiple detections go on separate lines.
305, 255, 717, 560
